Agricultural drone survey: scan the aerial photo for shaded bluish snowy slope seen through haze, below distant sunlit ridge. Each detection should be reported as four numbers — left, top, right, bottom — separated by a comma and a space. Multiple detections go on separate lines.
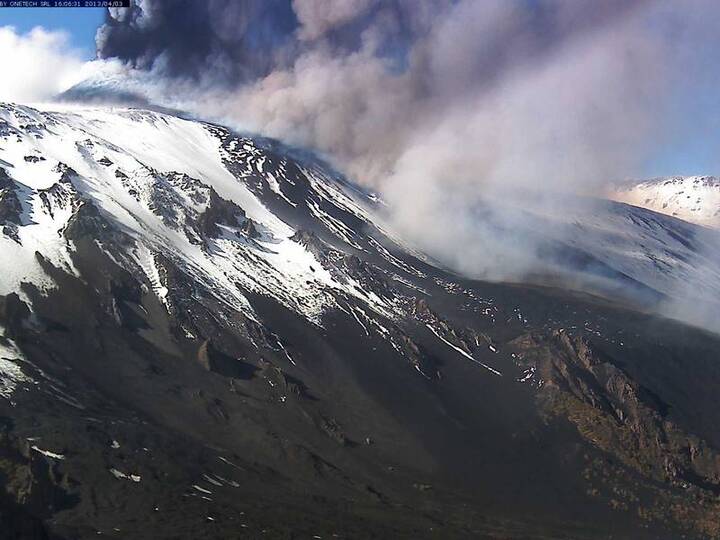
504, 197, 720, 312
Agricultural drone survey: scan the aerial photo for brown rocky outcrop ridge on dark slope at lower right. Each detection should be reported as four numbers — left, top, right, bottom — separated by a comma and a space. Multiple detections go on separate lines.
512, 329, 720, 493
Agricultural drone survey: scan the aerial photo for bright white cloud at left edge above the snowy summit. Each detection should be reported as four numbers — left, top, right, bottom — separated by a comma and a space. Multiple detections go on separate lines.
0, 26, 84, 103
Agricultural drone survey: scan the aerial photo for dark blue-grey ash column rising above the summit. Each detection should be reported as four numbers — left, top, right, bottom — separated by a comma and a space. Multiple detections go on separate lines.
96, 0, 298, 84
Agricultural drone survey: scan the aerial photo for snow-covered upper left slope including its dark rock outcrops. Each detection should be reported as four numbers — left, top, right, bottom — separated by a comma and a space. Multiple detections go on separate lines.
0, 105, 404, 322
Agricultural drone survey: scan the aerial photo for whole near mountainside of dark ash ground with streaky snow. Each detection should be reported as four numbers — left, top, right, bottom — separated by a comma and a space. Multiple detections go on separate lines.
0, 103, 720, 539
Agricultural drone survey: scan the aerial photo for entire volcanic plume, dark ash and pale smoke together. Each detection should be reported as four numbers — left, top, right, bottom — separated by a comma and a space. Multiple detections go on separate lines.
81, 0, 720, 326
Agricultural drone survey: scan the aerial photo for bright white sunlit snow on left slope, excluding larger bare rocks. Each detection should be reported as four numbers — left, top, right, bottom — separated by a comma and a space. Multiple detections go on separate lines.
0, 105, 400, 323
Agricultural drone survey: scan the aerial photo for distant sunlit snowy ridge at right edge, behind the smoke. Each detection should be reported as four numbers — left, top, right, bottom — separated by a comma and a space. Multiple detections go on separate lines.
609, 176, 720, 228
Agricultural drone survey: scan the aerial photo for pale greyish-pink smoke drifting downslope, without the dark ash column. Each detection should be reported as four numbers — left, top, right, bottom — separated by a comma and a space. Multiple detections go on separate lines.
122, 0, 692, 279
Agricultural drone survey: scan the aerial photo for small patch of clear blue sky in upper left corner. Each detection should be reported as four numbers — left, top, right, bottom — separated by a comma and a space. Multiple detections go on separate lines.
0, 8, 105, 59
